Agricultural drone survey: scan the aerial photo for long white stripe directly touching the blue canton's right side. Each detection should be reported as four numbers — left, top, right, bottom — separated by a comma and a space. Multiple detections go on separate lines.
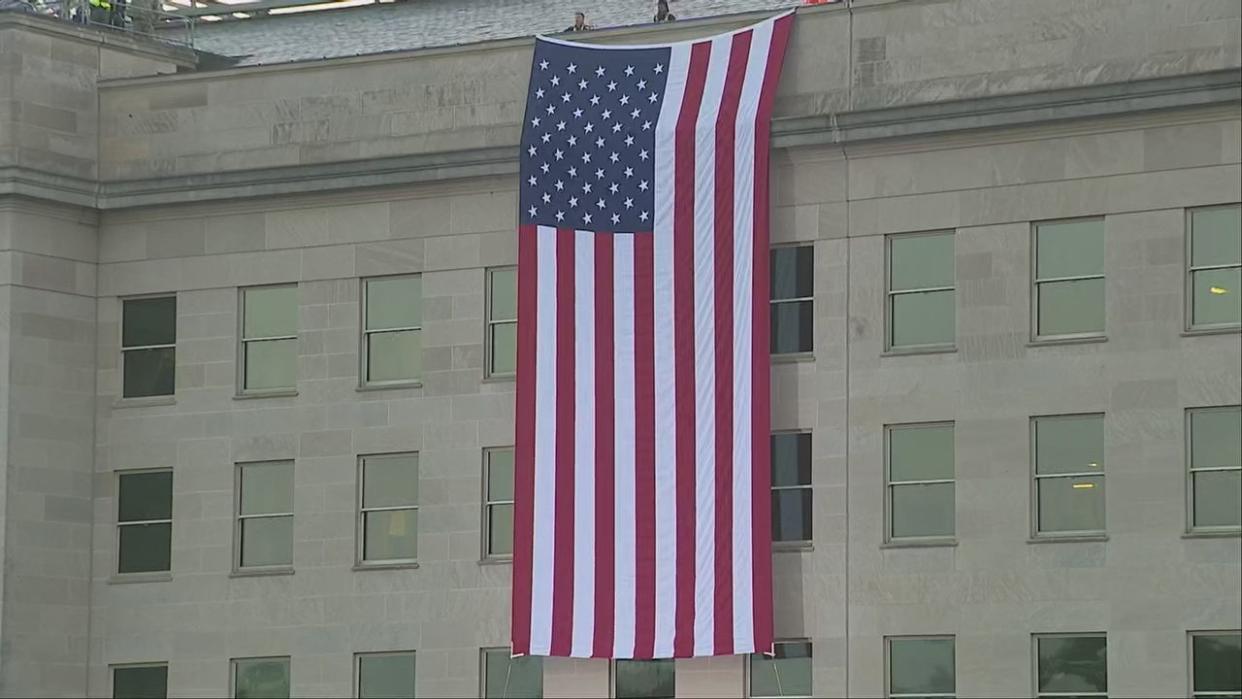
652, 45, 691, 658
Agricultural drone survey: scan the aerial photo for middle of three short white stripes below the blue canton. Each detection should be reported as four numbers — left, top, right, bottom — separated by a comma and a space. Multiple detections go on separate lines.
570, 231, 595, 658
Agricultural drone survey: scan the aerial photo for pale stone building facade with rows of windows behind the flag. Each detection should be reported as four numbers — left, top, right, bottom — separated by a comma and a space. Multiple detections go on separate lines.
0, 0, 1242, 697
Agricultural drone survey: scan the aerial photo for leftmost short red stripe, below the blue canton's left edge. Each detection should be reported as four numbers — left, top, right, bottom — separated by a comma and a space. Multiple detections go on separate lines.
510, 226, 539, 656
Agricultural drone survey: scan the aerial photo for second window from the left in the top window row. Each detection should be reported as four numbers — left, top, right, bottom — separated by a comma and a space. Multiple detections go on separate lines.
241, 284, 298, 392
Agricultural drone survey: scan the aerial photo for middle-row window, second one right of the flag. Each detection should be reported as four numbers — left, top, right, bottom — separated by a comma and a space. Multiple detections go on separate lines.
888, 423, 956, 540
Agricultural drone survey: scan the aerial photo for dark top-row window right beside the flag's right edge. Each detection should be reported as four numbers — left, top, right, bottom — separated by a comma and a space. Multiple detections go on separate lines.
770, 245, 815, 354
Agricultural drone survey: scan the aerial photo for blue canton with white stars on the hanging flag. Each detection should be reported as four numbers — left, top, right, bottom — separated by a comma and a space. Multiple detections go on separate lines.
519, 40, 671, 232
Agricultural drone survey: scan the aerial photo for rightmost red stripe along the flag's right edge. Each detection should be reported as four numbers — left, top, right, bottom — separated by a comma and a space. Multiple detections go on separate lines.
750, 16, 794, 652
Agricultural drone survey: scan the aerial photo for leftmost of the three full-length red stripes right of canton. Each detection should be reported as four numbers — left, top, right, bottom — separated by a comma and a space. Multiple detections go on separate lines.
673, 42, 712, 658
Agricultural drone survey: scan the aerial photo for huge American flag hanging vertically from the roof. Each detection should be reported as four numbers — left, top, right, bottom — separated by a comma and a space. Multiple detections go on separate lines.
512, 14, 792, 658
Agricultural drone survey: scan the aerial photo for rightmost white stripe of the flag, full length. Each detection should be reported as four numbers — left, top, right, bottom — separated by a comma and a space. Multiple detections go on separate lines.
733, 22, 773, 653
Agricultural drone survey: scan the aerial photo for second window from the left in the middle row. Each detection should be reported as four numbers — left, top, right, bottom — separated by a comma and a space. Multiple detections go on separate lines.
236, 461, 293, 569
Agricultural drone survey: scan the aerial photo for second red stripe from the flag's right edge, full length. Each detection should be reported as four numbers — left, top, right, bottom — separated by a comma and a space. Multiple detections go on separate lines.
713, 31, 753, 656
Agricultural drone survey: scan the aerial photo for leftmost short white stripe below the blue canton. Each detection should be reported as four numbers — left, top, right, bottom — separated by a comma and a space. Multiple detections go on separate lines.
530, 226, 556, 656
